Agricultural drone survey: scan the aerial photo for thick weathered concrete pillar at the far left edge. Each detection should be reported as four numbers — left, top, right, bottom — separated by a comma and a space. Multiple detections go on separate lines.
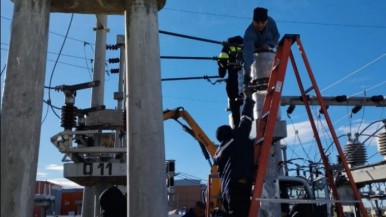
1, 0, 51, 217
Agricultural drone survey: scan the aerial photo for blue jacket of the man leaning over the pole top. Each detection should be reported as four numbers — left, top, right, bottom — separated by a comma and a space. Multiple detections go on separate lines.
243, 17, 280, 75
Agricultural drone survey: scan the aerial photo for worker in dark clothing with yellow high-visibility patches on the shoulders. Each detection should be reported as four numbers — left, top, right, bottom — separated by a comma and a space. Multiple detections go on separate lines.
217, 36, 244, 127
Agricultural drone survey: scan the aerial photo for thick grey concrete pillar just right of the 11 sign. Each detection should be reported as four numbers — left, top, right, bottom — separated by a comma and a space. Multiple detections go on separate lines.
125, 0, 167, 217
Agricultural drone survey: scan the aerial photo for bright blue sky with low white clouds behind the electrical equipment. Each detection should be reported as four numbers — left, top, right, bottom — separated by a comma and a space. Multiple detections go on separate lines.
1, 0, 386, 187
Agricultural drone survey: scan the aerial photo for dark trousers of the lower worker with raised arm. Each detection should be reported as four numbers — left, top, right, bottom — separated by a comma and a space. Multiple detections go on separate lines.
223, 183, 251, 217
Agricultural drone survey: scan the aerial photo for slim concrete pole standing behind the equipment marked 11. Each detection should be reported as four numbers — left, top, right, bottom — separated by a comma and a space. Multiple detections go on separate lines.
82, 15, 108, 217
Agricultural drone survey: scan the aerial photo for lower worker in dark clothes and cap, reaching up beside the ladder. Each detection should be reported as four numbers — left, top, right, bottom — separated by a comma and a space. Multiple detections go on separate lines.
215, 90, 254, 217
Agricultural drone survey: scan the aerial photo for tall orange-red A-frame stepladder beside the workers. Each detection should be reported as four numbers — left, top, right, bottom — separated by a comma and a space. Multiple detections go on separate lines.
249, 34, 367, 217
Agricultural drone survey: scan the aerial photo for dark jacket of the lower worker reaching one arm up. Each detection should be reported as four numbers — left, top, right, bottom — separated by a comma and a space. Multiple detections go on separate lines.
214, 98, 255, 192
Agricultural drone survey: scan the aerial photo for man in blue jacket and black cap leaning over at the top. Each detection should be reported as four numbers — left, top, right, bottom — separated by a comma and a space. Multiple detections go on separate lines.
243, 7, 280, 84
